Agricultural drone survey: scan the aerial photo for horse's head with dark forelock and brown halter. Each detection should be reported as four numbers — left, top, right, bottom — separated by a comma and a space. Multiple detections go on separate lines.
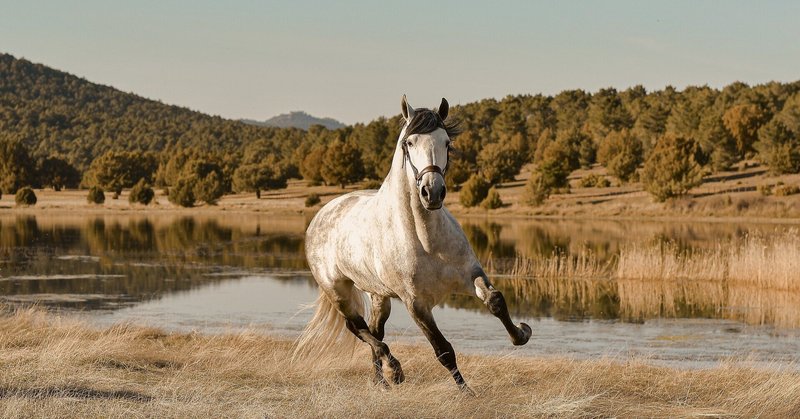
400, 95, 457, 211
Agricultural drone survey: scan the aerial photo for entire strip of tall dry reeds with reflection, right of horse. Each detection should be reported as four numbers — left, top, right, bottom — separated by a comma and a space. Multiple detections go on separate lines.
496, 230, 800, 328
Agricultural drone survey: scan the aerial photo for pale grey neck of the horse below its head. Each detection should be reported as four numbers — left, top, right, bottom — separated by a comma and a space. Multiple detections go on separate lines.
377, 147, 446, 251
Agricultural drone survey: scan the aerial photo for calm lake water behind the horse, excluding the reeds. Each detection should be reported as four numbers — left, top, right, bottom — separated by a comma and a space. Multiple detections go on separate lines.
0, 214, 800, 366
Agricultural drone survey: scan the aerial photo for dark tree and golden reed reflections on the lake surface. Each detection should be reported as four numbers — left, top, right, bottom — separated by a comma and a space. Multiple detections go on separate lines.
0, 214, 800, 327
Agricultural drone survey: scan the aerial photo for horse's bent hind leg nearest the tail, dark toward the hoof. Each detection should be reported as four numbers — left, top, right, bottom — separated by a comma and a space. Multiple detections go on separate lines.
324, 280, 405, 384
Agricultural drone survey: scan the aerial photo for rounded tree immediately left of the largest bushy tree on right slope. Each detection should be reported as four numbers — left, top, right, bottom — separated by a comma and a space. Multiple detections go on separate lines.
597, 129, 643, 182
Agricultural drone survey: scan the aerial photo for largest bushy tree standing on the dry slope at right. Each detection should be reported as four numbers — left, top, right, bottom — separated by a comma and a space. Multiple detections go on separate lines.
642, 134, 703, 202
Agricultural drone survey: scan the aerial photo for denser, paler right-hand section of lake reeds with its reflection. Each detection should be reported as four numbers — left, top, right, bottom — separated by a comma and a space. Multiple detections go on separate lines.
615, 230, 800, 328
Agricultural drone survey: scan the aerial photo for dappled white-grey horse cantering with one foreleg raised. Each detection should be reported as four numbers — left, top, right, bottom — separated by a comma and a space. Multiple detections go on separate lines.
293, 95, 531, 394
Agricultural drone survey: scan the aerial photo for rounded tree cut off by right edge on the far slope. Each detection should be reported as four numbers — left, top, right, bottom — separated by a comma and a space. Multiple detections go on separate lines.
755, 118, 800, 174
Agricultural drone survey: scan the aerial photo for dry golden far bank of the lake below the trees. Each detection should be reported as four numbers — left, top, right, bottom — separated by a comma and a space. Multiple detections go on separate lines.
0, 162, 800, 221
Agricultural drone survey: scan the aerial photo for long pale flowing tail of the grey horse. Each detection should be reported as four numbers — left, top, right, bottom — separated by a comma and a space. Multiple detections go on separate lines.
292, 287, 365, 362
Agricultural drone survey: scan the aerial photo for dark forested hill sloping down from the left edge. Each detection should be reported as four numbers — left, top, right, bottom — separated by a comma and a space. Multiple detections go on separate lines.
0, 54, 302, 169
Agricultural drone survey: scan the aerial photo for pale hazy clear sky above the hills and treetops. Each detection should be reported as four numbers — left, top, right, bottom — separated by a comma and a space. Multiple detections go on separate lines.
0, 0, 800, 124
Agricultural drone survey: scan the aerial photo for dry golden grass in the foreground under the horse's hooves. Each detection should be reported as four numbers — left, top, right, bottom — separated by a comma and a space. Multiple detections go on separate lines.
0, 311, 800, 418
